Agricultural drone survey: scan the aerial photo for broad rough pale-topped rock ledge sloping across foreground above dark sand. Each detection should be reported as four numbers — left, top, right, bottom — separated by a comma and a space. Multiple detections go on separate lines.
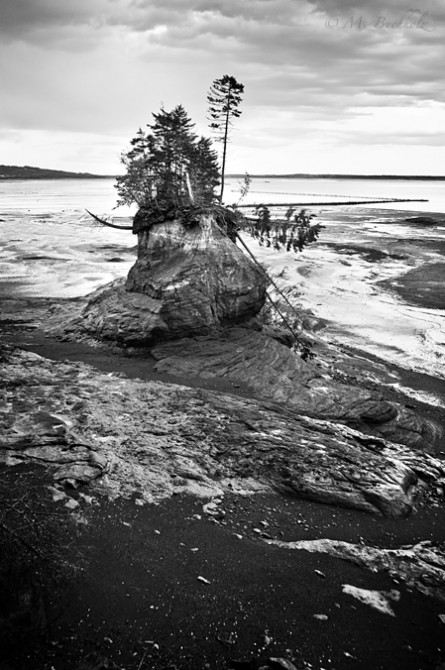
0, 348, 445, 517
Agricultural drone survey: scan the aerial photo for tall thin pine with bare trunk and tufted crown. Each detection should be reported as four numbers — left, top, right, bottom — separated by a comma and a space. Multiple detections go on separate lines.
207, 74, 244, 203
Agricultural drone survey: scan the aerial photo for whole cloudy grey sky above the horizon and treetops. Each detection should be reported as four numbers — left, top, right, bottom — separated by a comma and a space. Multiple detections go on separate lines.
0, 0, 445, 175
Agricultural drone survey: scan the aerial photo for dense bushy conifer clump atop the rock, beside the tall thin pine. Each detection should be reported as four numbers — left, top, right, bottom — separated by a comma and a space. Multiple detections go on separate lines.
116, 105, 219, 207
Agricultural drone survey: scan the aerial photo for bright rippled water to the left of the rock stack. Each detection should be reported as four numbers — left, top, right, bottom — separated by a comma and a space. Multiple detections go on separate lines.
0, 179, 136, 298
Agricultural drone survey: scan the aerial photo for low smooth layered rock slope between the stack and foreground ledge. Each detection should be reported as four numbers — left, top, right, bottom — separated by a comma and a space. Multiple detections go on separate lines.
151, 328, 442, 450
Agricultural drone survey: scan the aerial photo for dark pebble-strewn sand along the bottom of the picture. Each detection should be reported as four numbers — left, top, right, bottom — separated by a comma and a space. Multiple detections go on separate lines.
0, 468, 445, 670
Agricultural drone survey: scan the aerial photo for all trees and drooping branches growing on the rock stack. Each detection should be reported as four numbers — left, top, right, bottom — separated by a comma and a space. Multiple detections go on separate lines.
112, 86, 321, 258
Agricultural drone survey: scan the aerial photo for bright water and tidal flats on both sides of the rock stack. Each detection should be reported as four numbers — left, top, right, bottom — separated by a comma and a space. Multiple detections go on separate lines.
0, 178, 445, 394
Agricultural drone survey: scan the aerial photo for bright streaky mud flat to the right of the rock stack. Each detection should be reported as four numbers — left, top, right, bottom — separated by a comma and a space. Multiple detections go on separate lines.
248, 207, 445, 392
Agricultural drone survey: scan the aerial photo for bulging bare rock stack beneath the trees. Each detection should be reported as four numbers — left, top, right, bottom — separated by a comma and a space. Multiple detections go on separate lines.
73, 214, 267, 345
